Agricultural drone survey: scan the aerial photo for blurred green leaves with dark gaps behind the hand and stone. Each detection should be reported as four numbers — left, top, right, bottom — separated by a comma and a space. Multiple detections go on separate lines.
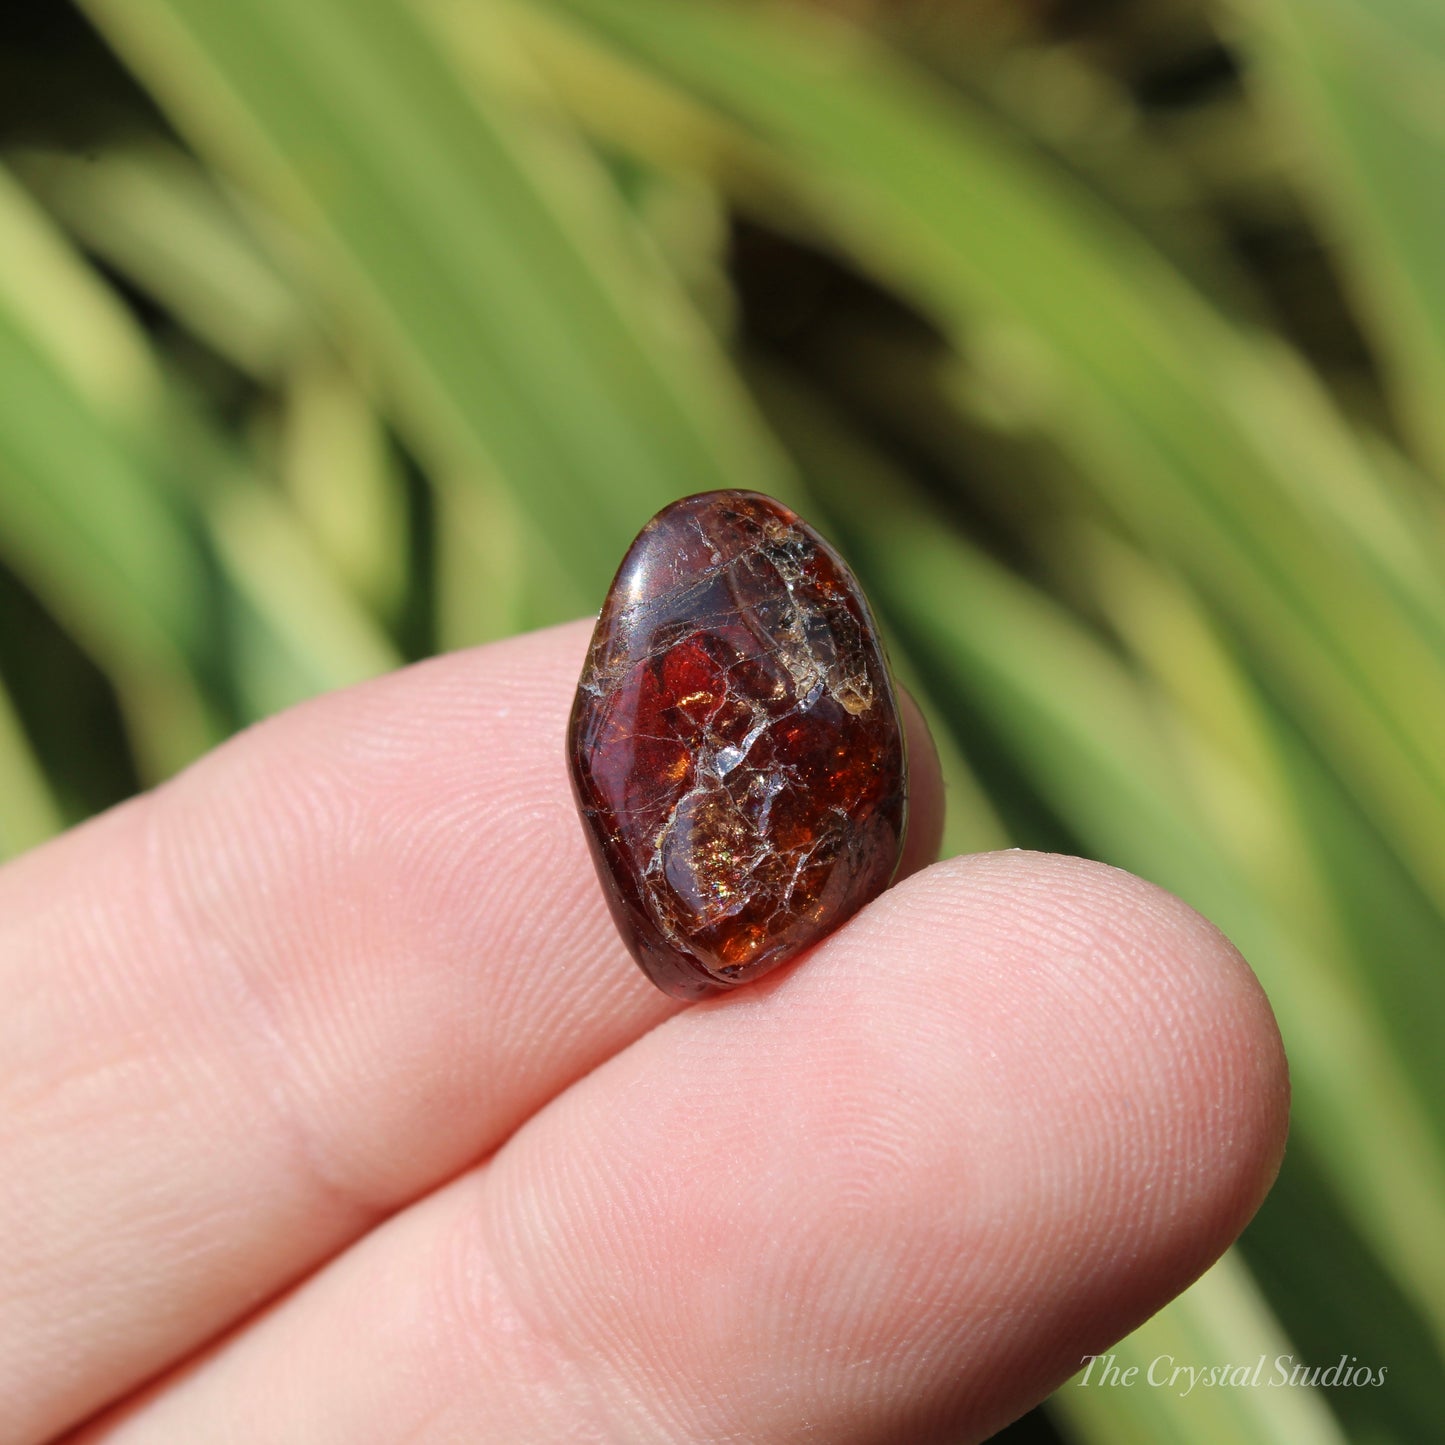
0, 0, 1445, 1445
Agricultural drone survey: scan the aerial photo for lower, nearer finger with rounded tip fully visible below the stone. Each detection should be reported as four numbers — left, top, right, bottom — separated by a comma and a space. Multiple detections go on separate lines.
73, 853, 1287, 1445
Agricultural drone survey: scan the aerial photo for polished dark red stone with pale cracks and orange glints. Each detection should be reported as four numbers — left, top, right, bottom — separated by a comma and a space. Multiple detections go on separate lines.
568, 491, 907, 998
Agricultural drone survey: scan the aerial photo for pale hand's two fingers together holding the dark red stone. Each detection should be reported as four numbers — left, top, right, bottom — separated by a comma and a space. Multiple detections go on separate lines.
0, 624, 1287, 1445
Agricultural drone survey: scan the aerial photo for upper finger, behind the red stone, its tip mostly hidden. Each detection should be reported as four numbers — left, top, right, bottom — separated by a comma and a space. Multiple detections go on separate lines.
0, 624, 939, 1441
